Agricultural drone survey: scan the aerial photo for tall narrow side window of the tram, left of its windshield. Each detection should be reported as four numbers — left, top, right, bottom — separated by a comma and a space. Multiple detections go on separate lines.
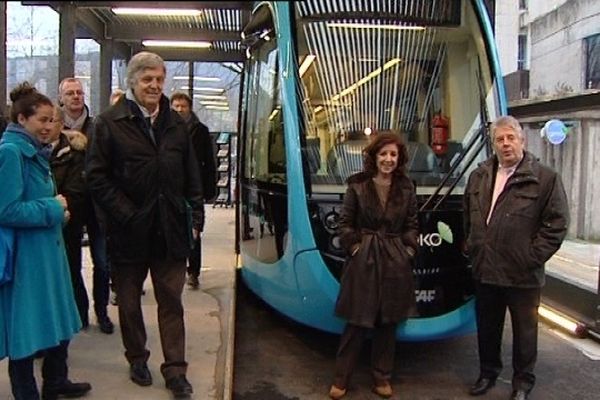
241, 6, 288, 263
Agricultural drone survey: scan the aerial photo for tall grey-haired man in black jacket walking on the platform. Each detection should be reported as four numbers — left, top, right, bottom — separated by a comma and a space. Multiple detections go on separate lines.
87, 52, 204, 397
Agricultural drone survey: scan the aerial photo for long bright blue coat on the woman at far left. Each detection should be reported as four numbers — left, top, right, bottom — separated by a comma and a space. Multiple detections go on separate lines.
0, 124, 81, 360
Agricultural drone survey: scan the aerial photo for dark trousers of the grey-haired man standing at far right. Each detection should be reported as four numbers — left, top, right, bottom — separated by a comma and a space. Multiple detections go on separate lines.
475, 283, 541, 391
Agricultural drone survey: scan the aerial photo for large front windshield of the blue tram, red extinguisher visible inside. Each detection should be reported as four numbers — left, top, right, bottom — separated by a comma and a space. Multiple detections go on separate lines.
295, 0, 498, 194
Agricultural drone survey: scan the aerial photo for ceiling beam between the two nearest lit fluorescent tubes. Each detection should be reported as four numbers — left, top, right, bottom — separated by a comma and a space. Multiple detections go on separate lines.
106, 23, 240, 41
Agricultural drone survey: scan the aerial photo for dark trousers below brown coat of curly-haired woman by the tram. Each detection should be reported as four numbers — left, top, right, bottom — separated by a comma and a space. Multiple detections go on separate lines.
333, 324, 397, 389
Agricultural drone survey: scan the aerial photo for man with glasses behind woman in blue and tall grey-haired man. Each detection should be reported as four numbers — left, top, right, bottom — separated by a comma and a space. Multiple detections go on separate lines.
58, 78, 114, 334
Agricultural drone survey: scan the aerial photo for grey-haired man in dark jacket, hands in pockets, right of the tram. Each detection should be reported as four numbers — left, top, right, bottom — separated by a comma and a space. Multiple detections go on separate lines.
464, 116, 569, 400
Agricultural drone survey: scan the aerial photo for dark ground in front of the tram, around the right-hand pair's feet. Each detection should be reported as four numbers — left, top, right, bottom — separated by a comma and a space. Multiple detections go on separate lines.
233, 281, 600, 400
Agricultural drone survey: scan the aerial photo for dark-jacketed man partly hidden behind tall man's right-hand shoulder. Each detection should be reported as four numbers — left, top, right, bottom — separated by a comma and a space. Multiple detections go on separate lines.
171, 92, 217, 289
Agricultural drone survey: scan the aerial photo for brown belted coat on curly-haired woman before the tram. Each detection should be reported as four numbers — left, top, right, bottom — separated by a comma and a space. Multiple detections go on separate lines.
335, 172, 418, 328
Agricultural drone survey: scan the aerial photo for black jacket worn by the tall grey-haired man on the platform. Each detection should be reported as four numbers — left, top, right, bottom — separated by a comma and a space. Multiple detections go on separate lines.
86, 95, 204, 264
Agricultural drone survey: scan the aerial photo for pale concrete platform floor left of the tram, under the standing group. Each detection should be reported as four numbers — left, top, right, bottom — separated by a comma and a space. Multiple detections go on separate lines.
0, 206, 236, 400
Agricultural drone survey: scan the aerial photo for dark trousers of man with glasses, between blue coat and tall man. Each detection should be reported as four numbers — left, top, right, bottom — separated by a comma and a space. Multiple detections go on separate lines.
87, 206, 110, 318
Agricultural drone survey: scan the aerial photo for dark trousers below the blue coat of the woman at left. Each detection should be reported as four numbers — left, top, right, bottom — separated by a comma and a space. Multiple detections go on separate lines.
8, 340, 69, 400
